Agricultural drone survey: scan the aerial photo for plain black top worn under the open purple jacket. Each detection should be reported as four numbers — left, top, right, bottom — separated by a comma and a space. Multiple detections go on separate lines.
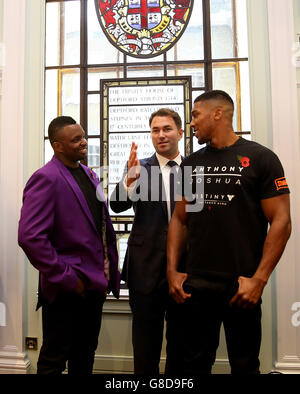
67, 166, 103, 235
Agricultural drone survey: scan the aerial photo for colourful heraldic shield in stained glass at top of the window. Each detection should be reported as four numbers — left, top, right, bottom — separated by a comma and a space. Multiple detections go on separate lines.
95, 0, 194, 58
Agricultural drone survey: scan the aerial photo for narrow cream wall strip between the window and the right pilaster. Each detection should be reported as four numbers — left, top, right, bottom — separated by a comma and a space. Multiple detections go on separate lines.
248, 0, 275, 373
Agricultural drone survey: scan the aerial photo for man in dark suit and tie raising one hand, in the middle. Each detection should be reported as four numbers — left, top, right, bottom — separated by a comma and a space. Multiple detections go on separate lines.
110, 108, 183, 375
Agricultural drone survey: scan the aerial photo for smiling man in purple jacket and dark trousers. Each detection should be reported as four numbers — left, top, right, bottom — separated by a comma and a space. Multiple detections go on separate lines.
19, 116, 120, 374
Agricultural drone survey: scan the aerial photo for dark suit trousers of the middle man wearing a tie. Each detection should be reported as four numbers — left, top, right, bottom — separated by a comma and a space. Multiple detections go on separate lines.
129, 283, 182, 376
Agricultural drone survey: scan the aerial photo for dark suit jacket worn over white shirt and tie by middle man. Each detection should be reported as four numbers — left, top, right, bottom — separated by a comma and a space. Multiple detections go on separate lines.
110, 154, 182, 294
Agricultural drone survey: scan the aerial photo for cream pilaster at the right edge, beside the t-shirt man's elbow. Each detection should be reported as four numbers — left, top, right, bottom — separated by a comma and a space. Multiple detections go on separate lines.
268, 0, 300, 373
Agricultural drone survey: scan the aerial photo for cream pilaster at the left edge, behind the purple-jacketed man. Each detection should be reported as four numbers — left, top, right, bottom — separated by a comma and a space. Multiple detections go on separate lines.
0, 0, 29, 373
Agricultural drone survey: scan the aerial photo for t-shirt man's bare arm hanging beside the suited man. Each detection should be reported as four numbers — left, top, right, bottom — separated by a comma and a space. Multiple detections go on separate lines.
167, 200, 190, 303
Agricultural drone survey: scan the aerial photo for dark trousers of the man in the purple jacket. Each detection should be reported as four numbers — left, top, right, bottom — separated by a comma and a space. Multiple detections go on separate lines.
37, 293, 105, 375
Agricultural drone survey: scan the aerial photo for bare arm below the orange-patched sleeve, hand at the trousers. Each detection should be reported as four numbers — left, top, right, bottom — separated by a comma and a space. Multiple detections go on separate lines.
231, 194, 291, 308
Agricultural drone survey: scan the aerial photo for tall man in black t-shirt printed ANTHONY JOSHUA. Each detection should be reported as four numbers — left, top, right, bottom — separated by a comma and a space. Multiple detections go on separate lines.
167, 91, 291, 375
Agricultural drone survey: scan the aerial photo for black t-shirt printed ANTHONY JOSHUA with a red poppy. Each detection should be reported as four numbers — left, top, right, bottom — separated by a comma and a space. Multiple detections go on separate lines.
178, 138, 289, 278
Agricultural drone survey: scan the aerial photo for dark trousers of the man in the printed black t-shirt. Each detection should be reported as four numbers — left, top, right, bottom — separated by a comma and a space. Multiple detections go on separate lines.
181, 286, 261, 375
